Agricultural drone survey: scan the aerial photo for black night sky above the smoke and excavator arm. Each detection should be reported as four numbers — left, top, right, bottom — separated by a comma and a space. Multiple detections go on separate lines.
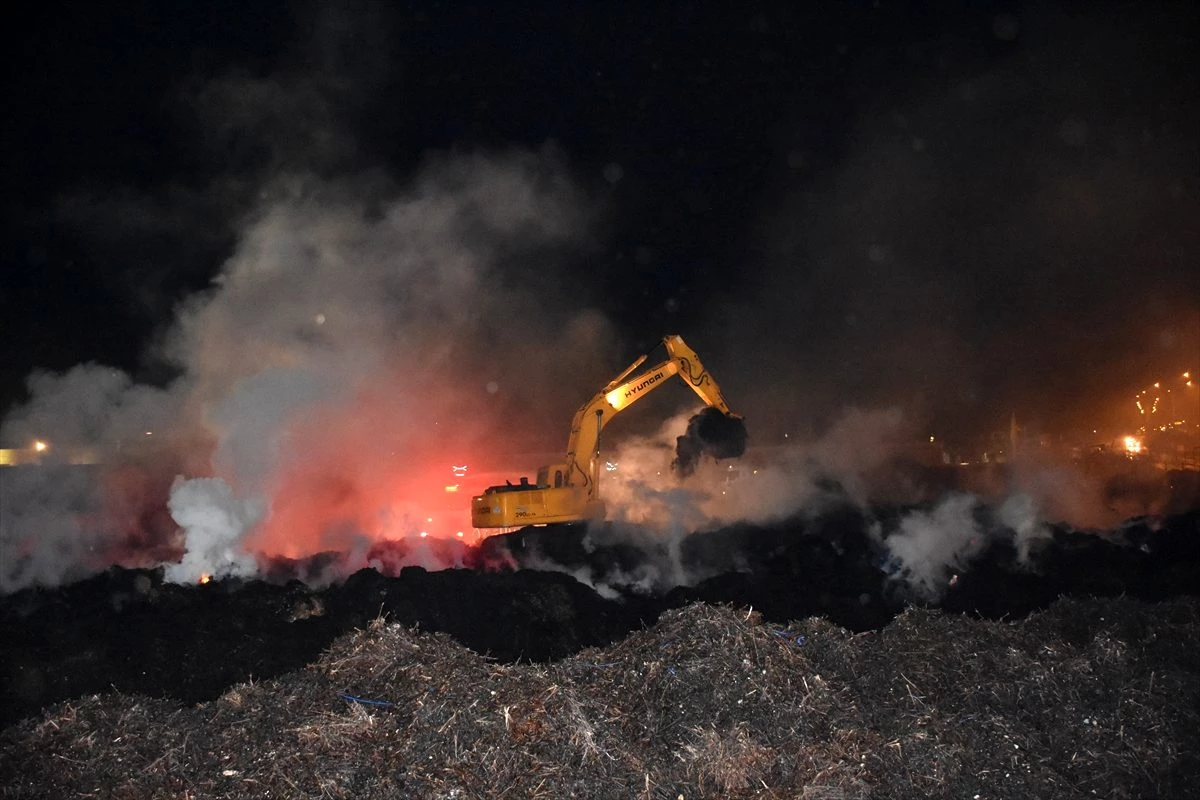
0, 0, 1200, 439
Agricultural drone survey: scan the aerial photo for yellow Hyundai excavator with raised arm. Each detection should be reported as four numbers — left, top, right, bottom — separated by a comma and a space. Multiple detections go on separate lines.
470, 335, 740, 528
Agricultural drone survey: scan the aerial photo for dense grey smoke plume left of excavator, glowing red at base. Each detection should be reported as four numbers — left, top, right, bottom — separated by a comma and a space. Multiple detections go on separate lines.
0, 146, 610, 590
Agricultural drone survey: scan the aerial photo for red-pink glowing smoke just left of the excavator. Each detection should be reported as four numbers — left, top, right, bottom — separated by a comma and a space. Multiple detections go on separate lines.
187, 368, 529, 566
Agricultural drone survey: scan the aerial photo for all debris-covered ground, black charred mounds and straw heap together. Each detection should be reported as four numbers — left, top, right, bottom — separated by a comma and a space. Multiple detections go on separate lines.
0, 512, 1200, 800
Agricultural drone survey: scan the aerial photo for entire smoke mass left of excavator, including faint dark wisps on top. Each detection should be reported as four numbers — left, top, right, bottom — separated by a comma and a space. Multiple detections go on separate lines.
0, 5, 619, 591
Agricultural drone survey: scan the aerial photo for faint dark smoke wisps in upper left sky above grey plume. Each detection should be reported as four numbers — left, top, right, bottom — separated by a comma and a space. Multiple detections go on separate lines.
22, 2, 398, 340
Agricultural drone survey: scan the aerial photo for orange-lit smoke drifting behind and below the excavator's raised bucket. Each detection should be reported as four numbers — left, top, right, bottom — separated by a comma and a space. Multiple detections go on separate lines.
522, 408, 908, 596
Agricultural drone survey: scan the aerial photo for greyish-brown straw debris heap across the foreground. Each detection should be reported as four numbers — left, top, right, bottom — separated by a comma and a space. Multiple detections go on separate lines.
0, 599, 1200, 799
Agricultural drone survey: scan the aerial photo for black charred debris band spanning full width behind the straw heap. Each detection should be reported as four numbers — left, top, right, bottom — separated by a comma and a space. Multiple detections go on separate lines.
0, 507, 1200, 726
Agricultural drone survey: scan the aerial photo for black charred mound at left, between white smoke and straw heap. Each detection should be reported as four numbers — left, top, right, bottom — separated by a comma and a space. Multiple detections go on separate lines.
0, 567, 656, 726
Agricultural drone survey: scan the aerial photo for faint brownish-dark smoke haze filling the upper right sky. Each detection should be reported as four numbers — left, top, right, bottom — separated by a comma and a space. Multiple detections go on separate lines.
726, 4, 1200, 443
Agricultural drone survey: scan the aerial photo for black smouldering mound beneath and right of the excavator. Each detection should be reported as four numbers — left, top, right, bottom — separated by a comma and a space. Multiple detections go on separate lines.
480, 503, 1200, 631
